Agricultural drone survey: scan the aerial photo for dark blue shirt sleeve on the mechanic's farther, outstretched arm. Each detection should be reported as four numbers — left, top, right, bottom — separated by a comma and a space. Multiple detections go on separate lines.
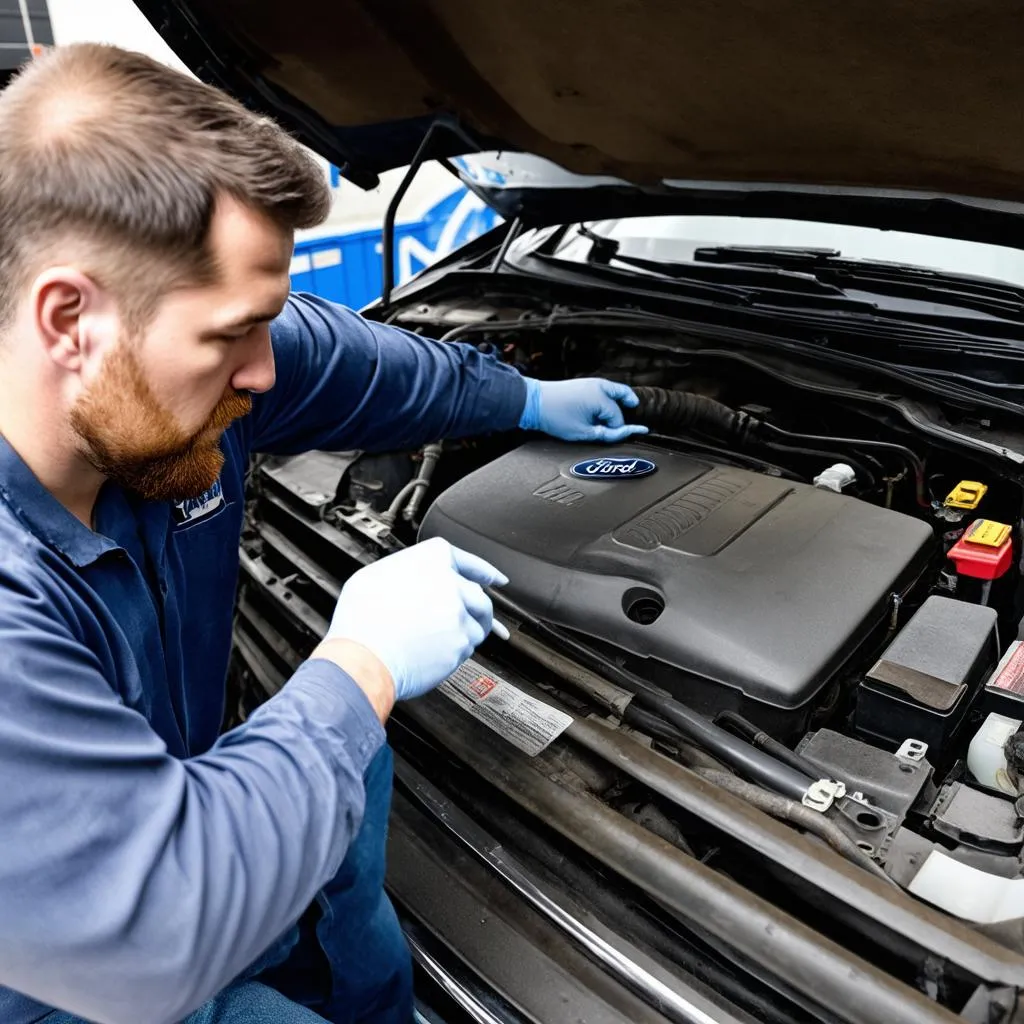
251, 294, 526, 455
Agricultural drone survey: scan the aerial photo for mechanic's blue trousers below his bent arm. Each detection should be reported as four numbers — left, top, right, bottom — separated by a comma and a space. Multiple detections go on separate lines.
39, 746, 413, 1024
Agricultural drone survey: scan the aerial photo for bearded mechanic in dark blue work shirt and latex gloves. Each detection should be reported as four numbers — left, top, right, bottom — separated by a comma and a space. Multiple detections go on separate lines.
0, 45, 642, 1024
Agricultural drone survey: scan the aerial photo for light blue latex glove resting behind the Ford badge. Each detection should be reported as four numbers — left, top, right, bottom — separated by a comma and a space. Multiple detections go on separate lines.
519, 377, 647, 441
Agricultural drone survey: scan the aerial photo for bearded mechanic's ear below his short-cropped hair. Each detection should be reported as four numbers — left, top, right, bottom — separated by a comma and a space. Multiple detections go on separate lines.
31, 266, 117, 375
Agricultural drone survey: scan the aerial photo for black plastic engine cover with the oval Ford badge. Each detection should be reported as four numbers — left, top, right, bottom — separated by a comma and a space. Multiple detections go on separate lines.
420, 441, 932, 731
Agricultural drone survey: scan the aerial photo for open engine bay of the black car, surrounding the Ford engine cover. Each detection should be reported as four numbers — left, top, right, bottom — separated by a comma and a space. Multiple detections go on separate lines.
237, 294, 1024, 1019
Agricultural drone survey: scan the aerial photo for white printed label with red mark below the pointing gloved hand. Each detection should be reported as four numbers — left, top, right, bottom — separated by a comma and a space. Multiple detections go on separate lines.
438, 662, 572, 757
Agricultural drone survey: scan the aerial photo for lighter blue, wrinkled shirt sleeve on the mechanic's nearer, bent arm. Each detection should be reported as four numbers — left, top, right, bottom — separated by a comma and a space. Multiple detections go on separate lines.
0, 567, 384, 1024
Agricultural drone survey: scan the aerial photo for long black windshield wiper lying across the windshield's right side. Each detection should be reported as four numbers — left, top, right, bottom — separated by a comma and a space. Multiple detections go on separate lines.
693, 246, 1024, 321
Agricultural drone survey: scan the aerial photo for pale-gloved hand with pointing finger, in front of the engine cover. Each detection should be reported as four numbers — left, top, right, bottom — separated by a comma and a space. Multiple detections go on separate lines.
326, 538, 508, 700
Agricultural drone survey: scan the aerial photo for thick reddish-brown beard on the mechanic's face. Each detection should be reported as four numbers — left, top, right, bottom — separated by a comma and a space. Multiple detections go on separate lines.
71, 339, 252, 502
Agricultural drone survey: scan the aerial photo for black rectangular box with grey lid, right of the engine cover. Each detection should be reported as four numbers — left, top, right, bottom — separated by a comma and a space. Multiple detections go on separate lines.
854, 596, 998, 763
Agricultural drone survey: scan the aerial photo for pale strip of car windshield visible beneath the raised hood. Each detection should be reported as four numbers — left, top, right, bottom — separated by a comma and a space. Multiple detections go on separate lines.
536, 216, 1024, 286
